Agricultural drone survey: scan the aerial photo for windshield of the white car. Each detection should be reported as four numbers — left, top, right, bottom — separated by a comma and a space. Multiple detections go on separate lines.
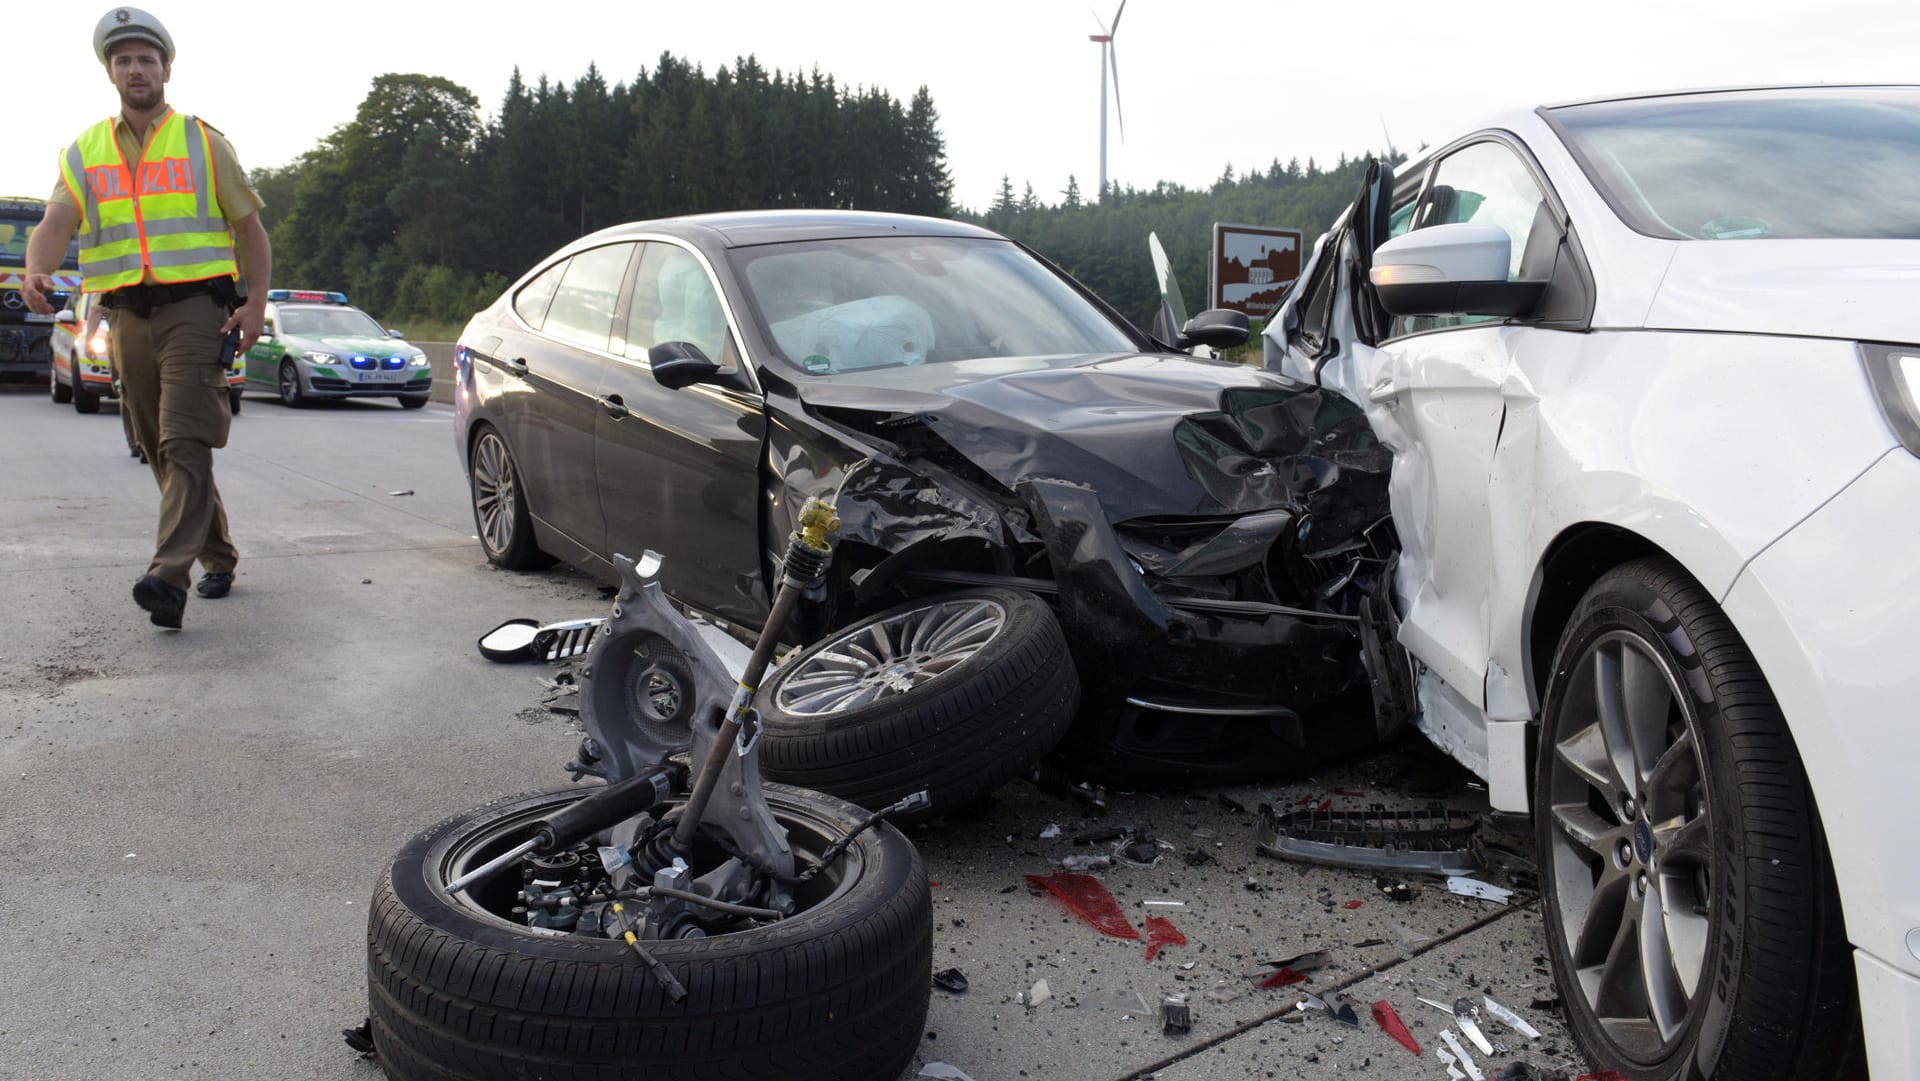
1549, 88, 1920, 240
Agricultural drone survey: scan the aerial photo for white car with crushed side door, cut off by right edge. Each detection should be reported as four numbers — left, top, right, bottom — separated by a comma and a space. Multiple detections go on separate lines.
1265, 86, 1920, 1081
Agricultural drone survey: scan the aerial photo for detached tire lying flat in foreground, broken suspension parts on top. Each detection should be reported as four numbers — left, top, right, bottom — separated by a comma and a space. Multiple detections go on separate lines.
367, 785, 933, 1081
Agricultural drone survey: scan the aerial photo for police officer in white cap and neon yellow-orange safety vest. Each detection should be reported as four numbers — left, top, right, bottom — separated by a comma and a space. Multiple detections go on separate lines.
21, 8, 273, 628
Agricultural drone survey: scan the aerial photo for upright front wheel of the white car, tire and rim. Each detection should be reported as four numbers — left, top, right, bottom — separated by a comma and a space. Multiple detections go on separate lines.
1534, 559, 1859, 1081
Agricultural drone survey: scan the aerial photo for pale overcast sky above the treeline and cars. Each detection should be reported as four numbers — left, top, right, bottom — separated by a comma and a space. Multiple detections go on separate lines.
0, 0, 1920, 209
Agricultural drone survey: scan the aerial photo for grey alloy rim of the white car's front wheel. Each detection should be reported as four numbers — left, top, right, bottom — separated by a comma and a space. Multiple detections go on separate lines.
1548, 630, 1716, 1062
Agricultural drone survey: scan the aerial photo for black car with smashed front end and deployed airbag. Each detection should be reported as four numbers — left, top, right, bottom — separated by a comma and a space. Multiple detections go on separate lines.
455, 211, 1411, 806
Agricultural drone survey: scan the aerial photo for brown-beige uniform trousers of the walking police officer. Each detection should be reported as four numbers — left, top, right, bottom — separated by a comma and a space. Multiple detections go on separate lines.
108, 296, 240, 589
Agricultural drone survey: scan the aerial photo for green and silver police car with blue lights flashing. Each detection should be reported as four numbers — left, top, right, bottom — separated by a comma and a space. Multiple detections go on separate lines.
246, 290, 434, 409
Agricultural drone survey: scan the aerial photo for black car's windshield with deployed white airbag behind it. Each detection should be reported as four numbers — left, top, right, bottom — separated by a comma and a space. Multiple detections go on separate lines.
732, 236, 1135, 376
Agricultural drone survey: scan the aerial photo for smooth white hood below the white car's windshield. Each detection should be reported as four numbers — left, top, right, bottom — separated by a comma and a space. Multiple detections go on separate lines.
1645, 240, 1920, 342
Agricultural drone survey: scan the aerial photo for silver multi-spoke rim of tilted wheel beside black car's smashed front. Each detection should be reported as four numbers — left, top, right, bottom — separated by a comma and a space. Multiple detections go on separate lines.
774, 597, 1006, 716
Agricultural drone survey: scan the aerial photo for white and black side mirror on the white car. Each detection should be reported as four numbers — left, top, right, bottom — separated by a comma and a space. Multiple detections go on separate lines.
1369, 221, 1548, 315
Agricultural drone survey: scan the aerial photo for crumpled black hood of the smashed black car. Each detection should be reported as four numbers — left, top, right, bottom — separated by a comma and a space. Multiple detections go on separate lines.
803, 355, 1384, 522
